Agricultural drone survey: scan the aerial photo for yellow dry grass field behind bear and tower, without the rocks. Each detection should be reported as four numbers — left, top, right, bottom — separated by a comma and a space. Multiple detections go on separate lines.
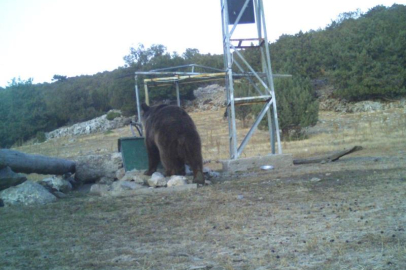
17, 109, 406, 163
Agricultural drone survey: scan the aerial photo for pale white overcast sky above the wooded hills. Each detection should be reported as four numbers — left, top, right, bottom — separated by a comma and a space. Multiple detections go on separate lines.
0, 0, 406, 87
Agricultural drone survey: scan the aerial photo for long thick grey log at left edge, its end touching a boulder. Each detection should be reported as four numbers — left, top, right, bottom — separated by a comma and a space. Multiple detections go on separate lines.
0, 149, 76, 175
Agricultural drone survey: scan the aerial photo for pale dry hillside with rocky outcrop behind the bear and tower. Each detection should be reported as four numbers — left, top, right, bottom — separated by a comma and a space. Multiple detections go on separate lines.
16, 85, 406, 163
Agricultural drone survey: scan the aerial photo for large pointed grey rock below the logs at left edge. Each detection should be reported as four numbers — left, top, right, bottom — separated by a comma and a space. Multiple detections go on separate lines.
0, 180, 57, 206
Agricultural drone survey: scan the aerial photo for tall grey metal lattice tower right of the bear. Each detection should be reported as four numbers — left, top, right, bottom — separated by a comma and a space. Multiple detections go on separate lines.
220, 0, 285, 160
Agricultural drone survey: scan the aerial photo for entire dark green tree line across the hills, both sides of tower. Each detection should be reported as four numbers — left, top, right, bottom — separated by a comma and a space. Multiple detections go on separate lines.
0, 5, 406, 147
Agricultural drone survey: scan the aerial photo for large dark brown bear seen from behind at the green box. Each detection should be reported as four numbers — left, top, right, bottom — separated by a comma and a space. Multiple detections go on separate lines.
141, 103, 204, 184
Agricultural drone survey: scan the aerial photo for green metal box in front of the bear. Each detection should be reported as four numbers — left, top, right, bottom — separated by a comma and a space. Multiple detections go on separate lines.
118, 137, 148, 171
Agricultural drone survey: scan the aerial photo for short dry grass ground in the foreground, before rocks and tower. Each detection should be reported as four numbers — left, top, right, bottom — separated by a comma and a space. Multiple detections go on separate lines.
0, 169, 406, 269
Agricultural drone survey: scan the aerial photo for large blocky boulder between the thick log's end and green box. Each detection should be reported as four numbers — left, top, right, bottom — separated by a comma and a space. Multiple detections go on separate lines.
75, 154, 121, 183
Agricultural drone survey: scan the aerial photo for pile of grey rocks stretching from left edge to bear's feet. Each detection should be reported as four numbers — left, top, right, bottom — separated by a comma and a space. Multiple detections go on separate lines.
0, 153, 220, 206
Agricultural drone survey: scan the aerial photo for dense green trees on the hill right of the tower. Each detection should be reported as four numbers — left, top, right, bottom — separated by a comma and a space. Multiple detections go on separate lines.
270, 4, 406, 101
